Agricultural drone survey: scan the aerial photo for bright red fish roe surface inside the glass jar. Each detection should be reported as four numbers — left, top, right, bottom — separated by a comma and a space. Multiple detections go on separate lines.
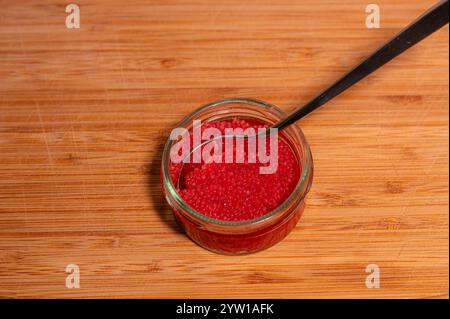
171, 119, 300, 221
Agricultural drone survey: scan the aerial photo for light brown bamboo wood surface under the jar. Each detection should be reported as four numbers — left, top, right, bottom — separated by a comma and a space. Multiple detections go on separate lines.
0, 0, 449, 298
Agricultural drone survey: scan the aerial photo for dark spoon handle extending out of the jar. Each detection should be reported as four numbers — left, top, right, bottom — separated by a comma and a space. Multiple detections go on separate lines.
272, 0, 449, 130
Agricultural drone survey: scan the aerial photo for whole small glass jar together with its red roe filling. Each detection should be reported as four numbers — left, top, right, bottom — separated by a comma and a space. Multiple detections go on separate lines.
161, 98, 314, 255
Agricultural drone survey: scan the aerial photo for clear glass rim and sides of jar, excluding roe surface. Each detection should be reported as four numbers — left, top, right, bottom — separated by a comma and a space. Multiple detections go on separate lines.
161, 98, 313, 255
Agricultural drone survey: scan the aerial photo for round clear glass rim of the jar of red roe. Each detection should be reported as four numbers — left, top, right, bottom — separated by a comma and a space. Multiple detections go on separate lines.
161, 98, 313, 226
